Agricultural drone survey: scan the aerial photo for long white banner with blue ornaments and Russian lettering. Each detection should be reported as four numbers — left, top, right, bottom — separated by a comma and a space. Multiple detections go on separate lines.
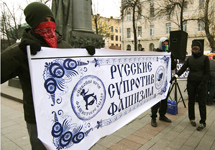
28, 48, 171, 150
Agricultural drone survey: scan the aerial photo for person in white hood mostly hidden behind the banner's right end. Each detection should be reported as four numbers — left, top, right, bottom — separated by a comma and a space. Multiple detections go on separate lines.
151, 37, 172, 127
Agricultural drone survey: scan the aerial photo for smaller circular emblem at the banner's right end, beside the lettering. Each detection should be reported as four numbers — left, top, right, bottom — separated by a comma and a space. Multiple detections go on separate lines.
155, 66, 165, 89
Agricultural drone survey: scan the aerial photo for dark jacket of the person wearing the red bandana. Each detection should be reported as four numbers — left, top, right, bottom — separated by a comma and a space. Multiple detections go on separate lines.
1, 29, 71, 123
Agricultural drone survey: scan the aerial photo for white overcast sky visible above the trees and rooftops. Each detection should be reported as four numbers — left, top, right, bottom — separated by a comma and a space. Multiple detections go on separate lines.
0, 0, 121, 18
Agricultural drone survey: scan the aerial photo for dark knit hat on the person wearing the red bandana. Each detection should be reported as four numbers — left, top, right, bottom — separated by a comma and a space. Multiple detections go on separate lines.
24, 2, 54, 29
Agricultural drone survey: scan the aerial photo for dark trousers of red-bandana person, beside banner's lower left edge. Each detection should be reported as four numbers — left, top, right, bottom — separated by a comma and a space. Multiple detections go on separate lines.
27, 123, 46, 150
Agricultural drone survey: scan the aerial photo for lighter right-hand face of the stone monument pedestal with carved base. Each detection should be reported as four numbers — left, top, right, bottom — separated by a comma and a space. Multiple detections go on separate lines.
71, 0, 104, 48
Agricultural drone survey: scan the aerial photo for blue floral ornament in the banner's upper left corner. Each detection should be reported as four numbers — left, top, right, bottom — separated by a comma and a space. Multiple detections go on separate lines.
43, 58, 89, 106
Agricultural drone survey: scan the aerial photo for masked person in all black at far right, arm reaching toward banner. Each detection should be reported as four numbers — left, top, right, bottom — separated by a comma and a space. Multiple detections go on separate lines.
170, 41, 210, 131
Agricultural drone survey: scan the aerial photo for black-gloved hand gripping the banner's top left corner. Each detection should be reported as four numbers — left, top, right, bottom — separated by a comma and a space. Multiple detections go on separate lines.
19, 38, 41, 55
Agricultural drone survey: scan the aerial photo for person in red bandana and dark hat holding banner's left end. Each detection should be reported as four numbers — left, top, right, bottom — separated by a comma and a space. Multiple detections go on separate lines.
1, 2, 95, 150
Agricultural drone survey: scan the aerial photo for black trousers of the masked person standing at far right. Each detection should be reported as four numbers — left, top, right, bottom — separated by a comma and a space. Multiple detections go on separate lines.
187, 81, 207, 124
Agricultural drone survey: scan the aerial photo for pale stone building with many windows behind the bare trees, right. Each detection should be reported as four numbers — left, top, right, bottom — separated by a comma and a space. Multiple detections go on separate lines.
121, 0, 215, 54
